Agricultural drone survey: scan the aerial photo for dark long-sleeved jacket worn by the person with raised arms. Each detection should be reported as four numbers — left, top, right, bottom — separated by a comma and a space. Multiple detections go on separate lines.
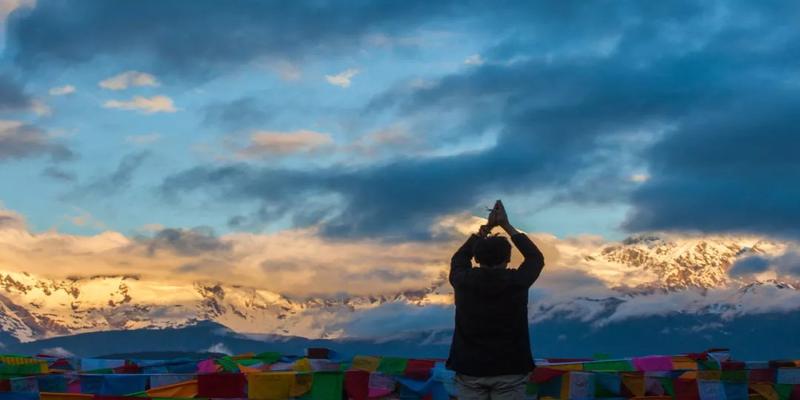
447, 233, 544, 376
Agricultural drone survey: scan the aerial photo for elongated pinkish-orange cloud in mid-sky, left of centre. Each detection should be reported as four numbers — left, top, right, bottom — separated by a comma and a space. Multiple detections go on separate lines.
237, 130, 333, 159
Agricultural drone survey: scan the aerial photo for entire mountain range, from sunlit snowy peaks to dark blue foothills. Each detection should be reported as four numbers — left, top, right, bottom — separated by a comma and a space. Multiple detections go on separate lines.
0, 234, 800, 359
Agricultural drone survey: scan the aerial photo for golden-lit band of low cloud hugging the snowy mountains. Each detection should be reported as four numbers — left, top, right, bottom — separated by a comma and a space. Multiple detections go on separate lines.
0, 203, 800, 336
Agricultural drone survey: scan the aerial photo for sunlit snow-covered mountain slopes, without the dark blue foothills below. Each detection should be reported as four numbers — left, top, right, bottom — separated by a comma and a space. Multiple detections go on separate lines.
0, 231, 800, 342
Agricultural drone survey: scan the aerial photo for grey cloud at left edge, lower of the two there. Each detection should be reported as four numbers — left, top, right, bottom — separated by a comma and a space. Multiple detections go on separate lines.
0, 120, 75, 162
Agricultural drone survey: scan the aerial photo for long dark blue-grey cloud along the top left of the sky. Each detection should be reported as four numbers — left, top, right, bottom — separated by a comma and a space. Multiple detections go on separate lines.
7, 0, 462, 76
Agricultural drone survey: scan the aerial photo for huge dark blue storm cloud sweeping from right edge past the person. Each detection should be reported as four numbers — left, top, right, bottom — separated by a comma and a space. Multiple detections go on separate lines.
163, 2, 800, 238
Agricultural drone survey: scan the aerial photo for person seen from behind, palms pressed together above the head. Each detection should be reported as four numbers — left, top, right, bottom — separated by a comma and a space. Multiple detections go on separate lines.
446, 200, 544, 400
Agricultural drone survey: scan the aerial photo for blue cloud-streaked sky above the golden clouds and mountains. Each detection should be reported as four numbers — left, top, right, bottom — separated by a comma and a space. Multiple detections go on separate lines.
0, 1, 800, 242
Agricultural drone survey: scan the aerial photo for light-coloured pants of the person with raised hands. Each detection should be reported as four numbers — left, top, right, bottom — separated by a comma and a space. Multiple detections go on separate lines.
455, 374, 529, 400
